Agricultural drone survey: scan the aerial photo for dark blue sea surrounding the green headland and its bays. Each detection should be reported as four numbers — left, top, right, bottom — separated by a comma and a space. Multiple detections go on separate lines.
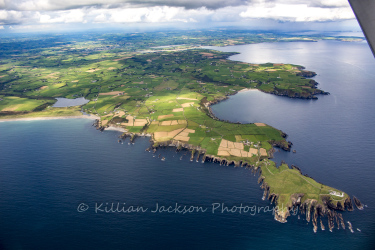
0, 42, 375, 249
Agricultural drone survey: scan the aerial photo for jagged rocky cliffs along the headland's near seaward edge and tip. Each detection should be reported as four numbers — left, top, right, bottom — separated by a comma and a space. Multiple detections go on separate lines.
99, 120, 363, 232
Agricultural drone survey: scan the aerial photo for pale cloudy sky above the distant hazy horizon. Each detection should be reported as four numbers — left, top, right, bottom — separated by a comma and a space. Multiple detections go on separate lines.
0, 0, 360, 32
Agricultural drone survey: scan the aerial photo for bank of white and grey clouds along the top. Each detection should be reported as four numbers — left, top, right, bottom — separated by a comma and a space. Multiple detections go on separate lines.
0, 0, 354, 27
